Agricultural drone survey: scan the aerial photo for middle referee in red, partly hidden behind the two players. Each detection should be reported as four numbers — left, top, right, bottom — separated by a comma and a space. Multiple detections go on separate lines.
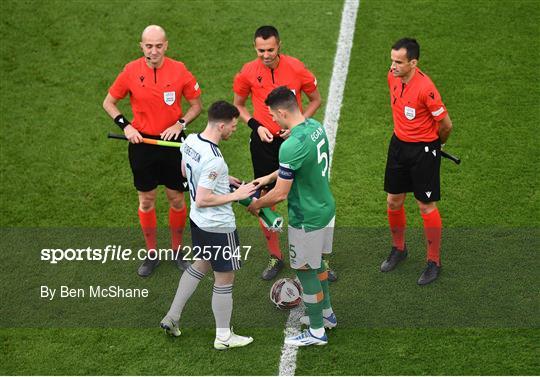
233, 25, 337, 281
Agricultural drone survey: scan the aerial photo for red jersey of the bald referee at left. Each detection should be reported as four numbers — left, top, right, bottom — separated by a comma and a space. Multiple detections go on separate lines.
109, 57, 201, 135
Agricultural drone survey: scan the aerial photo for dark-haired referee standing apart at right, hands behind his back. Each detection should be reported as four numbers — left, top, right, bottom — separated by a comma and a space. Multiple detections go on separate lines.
381, 38, 452, 285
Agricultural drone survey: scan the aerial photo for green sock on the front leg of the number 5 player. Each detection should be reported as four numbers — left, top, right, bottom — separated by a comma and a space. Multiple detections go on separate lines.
296, 269, 323, 329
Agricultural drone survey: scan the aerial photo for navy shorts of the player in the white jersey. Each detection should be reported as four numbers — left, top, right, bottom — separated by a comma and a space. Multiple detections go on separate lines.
189, 218, 242, 272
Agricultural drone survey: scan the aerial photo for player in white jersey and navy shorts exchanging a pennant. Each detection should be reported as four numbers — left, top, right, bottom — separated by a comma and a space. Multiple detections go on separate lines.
161, 101, 255, 350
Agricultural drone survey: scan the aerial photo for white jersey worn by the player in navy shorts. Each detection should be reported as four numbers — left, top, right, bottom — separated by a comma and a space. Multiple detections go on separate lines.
180, 134, 236, 233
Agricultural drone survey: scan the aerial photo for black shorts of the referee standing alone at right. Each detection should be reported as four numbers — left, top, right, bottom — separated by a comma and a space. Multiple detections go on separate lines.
384, 135, 441, 203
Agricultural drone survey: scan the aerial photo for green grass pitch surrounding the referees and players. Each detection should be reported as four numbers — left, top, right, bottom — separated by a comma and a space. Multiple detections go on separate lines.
0, 0, 540, 375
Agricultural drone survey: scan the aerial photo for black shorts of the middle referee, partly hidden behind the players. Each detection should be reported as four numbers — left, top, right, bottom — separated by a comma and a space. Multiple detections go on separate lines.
249, 131, 284, 189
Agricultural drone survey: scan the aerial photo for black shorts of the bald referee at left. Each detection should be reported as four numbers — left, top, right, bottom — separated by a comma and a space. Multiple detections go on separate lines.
128, 132, 188, 192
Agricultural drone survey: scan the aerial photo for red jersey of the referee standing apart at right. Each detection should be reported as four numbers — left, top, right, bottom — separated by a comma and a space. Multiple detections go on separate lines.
388, 68, 447, 142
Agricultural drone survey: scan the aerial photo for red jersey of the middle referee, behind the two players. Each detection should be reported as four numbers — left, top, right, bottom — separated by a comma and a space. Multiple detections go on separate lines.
233, 55, 317, 136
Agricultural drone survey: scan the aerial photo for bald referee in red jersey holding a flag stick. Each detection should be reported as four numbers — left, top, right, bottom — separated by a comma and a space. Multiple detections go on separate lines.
103, 25, 202, 277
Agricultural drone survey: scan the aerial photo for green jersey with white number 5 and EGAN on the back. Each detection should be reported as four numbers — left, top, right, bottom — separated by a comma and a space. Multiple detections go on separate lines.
279, 119, 336, 231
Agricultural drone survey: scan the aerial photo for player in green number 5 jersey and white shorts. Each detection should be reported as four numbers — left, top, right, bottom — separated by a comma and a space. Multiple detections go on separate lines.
248, 86, 337, 346
